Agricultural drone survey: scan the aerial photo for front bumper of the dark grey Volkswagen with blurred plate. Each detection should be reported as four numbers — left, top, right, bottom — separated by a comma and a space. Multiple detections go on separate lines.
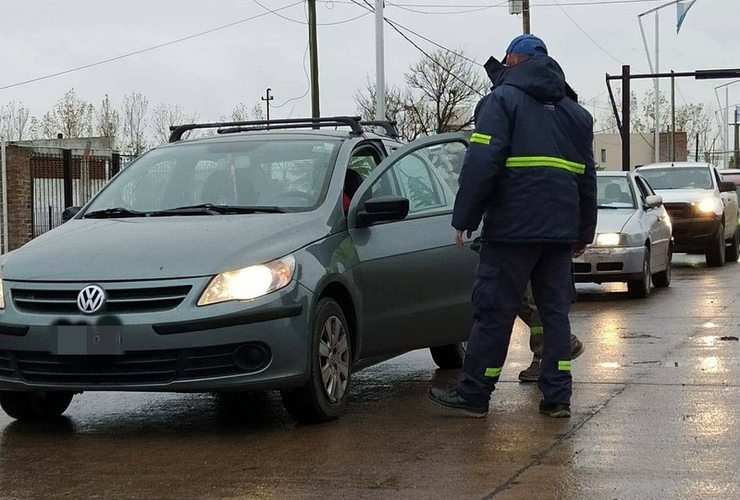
0, 278, 312, 392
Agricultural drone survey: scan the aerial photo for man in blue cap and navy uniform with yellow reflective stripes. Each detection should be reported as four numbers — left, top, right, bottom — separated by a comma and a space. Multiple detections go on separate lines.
428, 35, 597, 417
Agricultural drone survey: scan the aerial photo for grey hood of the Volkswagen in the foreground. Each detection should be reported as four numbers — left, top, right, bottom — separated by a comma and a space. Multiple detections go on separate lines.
0, 213, 329, 281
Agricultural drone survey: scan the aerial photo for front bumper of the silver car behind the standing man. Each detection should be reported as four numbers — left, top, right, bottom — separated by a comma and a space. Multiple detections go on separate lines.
573, 246, 645, 283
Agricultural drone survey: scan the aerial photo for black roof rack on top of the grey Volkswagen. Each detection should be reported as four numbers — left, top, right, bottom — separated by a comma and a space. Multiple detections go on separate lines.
170, 116, 365, 142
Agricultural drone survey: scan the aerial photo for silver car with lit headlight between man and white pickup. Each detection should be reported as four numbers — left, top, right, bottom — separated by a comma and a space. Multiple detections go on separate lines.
573, 171, 672, 298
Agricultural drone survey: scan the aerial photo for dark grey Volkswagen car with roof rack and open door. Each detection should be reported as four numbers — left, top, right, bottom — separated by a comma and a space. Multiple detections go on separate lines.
0, 117, 476, 422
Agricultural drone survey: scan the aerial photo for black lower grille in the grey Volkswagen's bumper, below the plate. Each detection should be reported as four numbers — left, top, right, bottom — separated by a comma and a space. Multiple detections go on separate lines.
0, 344, 269, 387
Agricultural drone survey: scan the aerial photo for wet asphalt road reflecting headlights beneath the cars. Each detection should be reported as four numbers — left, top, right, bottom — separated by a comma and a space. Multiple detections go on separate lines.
0, 255, 740, 500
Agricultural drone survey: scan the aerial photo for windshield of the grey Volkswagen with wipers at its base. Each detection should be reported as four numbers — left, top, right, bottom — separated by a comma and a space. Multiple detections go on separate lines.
86, 138, 341, 214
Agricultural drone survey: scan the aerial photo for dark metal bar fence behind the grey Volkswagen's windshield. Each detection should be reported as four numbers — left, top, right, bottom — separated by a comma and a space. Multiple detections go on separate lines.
30, 149, 133, 237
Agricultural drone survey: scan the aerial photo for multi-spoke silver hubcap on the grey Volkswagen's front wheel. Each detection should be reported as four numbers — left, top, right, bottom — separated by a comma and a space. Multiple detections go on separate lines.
319, 316, 349, 403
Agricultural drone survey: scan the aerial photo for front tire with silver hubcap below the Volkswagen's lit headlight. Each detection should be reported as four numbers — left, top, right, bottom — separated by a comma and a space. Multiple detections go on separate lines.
281, 297, 352, 423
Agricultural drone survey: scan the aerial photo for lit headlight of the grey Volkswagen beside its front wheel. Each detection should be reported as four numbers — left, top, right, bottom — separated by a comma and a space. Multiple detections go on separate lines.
198, 255, 295, 306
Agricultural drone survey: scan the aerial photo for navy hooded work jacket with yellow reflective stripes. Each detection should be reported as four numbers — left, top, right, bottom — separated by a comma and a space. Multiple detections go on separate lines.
452, 56, 597, 245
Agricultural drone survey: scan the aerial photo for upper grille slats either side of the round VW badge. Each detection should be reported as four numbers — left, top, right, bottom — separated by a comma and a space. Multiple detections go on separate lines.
11, 285, 192, 314
